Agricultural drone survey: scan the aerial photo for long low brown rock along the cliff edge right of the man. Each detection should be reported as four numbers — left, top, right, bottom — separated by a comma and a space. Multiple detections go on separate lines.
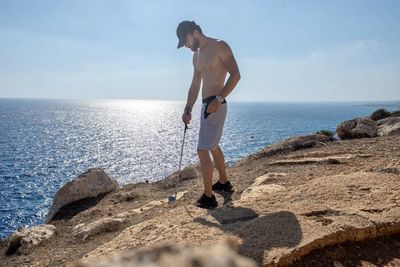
254, 134, 334, 159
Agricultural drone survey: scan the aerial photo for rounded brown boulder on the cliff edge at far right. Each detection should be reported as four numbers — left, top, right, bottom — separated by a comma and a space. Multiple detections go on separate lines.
336, 118, 378, 139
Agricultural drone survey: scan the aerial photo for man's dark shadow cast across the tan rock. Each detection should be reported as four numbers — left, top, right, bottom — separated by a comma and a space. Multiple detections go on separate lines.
194, 194, 303, 264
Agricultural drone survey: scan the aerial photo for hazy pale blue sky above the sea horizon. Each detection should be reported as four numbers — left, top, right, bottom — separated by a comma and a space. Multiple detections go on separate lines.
0, 0, 400, 102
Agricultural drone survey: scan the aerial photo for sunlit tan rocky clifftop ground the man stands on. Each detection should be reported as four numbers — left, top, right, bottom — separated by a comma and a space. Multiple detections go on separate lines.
0, 113, 400, 266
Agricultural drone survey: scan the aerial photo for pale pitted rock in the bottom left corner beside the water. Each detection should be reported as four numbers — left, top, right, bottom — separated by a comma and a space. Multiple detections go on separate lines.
6, 224, 56, 256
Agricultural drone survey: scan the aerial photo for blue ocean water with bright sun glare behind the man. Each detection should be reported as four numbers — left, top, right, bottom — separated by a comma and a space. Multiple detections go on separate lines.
0, 99, 382, 238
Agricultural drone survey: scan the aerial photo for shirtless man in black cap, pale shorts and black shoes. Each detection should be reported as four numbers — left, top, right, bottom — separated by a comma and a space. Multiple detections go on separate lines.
176, 21, 240, 209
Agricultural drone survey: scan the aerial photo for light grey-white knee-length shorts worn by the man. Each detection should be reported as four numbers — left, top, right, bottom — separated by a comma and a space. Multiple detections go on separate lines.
197, 103, 228, 150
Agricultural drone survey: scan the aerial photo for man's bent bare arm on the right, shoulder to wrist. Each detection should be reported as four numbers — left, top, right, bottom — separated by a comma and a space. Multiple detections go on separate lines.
219, 41, 240, 98
